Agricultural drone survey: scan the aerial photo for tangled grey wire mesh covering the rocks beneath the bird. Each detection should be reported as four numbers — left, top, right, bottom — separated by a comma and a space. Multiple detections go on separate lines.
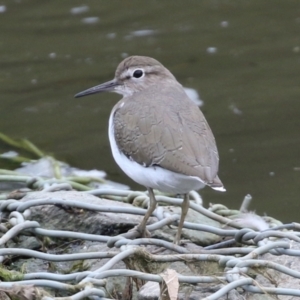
0, 175, 300, 300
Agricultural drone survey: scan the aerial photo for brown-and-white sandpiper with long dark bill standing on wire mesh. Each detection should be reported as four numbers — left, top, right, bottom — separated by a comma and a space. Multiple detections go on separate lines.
75, 55, 226, 244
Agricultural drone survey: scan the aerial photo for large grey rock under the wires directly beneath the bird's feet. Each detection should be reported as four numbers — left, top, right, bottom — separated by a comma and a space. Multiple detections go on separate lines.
21, 191, 220, 246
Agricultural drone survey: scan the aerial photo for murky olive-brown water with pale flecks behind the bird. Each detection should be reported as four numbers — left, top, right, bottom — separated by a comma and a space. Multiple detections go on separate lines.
0, 0, 300, 222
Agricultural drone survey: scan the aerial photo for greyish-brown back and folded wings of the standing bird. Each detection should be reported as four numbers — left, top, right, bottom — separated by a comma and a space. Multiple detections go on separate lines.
114, 86, 219, 183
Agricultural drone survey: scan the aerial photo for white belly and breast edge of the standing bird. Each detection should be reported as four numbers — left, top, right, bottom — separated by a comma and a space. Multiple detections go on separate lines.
108, 114, 205, 194
